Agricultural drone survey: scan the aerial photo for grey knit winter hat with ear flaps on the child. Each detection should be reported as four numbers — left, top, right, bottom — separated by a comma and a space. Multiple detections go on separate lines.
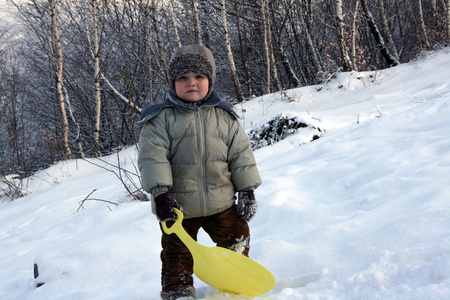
169, 45, 216, 99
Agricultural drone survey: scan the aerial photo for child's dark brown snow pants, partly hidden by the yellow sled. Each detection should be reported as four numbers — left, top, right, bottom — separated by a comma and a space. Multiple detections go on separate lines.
161, 206, 250, 292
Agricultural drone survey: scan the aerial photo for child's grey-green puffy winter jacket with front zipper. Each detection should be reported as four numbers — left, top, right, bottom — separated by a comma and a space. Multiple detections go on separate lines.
138, 92, 261, 218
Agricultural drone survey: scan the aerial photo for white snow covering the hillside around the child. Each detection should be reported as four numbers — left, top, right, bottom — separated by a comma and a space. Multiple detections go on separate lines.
0, 48, 450, 300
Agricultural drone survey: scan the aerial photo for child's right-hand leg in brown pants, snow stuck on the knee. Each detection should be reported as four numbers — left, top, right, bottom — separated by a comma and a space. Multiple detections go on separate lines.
202, 206, 250, 256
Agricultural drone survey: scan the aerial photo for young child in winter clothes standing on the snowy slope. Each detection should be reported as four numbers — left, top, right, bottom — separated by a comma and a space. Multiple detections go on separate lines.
138, 45, 261, 300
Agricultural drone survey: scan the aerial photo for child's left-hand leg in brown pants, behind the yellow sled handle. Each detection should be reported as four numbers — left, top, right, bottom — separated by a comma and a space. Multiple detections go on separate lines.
161, 219, 201, 300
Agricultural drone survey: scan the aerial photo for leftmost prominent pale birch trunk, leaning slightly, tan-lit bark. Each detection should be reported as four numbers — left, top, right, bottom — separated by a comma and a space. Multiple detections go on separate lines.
50, 0, 72, 158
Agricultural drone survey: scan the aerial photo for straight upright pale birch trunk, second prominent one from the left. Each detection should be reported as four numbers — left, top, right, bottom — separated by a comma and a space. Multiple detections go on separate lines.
92, 0, 102, 156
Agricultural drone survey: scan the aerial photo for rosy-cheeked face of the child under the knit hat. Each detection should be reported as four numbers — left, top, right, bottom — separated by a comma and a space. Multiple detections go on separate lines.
175, 73, 209, 102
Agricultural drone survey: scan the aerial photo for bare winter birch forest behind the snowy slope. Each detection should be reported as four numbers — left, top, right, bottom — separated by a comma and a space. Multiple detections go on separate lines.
0, 0, 450, 184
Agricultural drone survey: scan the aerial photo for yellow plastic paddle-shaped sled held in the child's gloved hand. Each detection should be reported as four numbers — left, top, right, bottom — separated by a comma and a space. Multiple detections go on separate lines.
162, 208, 275, 297
